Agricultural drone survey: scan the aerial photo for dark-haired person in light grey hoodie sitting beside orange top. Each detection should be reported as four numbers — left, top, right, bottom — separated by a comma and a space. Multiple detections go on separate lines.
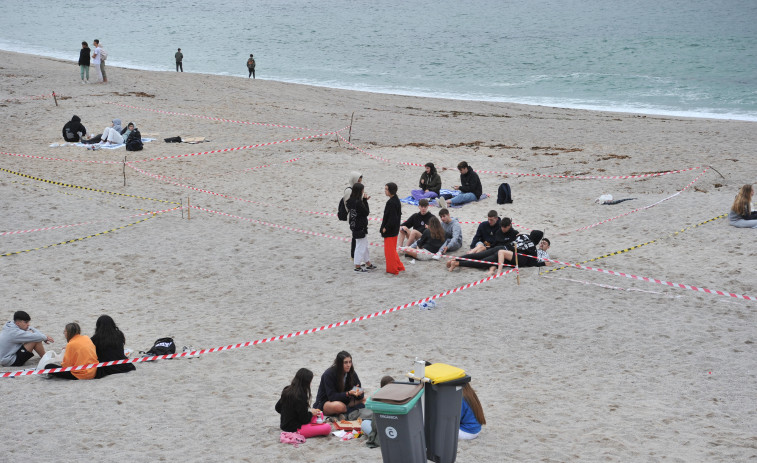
0, 310, 55, 367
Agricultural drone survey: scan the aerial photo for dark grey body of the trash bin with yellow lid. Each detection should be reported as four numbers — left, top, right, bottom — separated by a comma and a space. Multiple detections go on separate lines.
424, 375, 470, 463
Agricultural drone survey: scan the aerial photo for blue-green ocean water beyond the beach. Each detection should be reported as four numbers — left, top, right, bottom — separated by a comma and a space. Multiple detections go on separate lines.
0, 0, 757, 121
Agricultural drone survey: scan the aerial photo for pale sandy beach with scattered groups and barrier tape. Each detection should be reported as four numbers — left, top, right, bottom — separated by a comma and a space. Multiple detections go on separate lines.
0, 52, 757, 463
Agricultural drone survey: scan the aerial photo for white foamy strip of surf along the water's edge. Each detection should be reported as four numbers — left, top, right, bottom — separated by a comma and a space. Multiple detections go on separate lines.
0, 49, 757, 122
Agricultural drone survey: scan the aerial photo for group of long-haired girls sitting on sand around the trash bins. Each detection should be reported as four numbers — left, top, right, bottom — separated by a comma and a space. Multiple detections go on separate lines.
275, 351, 486, 439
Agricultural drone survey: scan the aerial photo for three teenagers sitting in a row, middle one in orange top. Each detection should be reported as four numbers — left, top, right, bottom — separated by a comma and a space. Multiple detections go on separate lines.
0, 310, 136, 379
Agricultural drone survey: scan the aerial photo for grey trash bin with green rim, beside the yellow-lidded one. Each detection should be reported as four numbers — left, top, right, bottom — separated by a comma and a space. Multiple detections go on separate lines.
365, 383, 426, 463
